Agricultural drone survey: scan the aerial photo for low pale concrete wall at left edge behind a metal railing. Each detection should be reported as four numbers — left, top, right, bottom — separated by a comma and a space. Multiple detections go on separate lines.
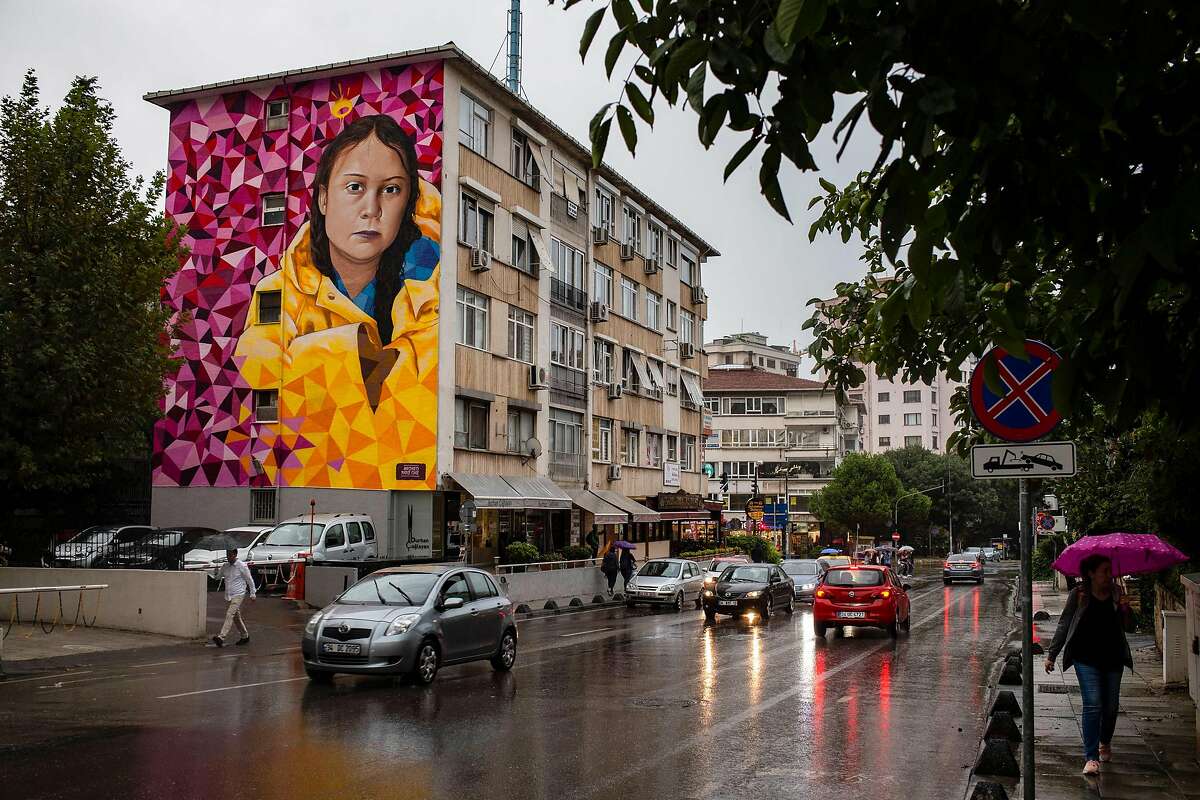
0, 567, 208, 638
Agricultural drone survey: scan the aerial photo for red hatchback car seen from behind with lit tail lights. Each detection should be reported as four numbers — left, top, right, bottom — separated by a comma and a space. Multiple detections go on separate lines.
812, 566, 912, 637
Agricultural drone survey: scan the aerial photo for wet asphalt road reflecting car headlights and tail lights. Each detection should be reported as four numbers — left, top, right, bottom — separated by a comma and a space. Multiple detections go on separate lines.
0, 567, 1012, 800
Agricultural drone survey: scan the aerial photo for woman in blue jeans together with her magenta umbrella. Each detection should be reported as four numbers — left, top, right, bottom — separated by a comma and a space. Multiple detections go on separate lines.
1045, 534, 1187, 775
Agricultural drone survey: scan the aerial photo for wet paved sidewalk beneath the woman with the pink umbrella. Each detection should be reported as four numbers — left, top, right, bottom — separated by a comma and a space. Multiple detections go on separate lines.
1009, 582, 1200, 800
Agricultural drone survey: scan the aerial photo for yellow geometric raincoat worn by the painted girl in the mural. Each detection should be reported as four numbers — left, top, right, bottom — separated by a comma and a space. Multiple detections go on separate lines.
236, 180, 442, 489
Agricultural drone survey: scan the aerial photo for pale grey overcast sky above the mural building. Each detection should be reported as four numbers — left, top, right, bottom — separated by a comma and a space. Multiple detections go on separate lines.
0, 0, 876, 367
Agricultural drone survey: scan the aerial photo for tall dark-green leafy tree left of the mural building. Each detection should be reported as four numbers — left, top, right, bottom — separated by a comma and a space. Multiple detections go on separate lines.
0, 71, 182, 497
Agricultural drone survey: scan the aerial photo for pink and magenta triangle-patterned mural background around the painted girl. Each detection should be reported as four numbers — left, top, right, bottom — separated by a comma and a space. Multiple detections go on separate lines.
152, 61, 443, 487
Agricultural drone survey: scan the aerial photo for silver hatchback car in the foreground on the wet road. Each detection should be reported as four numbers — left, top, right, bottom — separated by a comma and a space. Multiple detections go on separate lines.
300, 565, 517, 684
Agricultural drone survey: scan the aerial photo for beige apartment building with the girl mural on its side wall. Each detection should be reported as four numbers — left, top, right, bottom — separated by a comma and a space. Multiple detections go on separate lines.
146, 44, 718, 564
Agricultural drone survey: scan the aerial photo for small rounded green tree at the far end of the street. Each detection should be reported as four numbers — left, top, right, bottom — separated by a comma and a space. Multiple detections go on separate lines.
810, 452, 930, 537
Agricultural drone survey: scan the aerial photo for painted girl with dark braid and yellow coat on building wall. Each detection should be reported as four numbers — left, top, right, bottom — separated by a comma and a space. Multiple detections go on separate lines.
235, 114, 442, 488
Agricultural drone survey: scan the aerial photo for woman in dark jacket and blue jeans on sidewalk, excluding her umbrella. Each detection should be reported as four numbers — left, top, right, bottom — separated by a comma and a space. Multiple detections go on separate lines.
1045, 555, 1133, 775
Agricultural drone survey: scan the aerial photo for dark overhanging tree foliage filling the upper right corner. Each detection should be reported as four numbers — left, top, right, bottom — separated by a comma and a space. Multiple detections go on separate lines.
565, 0, 1200, 433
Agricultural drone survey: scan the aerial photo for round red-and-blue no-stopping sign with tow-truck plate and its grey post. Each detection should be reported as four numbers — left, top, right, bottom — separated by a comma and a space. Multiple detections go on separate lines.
968, 339, 1075, 800
